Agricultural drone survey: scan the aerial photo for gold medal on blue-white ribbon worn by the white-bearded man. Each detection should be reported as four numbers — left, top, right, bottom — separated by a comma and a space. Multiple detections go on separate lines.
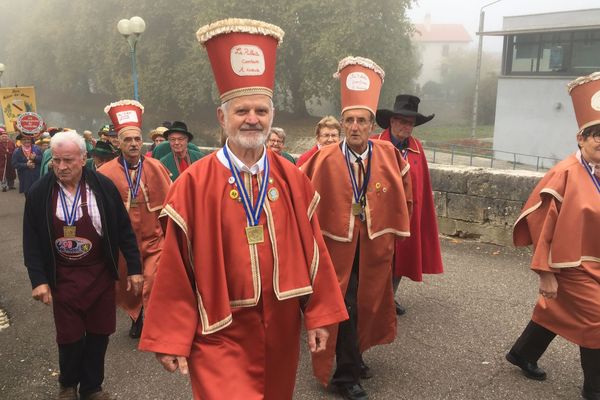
223, 147, 269, 245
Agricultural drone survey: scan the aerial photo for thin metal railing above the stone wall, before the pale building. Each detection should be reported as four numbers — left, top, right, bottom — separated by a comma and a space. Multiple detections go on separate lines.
423, 143, 560, 171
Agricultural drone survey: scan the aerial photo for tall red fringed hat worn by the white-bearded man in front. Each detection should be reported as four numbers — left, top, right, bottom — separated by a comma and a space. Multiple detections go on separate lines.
196, 18, 284, 103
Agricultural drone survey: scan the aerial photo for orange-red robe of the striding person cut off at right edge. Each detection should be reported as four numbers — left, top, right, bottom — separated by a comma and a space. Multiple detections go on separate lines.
513, 155, 600, 349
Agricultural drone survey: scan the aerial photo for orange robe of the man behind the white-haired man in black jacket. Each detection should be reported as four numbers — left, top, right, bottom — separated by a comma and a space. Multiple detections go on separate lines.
98, 157, 171, 320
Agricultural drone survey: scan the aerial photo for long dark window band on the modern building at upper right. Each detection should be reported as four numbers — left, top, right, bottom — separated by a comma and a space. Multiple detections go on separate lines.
504, 30, 600, 76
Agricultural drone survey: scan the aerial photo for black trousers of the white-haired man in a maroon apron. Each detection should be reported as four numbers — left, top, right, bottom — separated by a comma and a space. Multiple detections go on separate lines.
58, 333, 108, 396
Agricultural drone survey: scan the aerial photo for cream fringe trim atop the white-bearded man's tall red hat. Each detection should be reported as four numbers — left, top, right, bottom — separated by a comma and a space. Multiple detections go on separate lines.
196, 18, 284, 46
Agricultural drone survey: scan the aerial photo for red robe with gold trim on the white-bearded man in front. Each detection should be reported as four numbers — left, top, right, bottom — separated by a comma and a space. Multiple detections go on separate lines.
139, 151, 348, 400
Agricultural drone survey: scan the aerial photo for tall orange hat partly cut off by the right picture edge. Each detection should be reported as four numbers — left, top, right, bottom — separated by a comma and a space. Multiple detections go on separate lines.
568, 72, 600, 132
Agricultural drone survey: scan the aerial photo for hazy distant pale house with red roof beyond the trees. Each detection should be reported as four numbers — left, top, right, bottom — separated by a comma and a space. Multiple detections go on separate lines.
412, 14, 472, 87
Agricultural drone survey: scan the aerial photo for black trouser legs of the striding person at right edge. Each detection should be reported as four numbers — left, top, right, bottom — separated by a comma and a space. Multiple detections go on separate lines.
510, 321, 600, 395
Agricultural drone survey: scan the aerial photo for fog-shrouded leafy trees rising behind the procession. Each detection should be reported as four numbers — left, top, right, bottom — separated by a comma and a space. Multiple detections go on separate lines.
0, 0, 418, 134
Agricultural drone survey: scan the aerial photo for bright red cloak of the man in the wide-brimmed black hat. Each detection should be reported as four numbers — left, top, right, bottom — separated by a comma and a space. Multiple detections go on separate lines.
377, 129, 444, 282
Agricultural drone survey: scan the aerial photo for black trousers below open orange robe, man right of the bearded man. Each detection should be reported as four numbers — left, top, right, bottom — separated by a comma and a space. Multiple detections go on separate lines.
331, 241, 362, 386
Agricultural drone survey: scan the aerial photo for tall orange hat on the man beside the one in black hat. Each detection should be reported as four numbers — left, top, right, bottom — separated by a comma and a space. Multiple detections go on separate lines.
333, 57, 385, 115
